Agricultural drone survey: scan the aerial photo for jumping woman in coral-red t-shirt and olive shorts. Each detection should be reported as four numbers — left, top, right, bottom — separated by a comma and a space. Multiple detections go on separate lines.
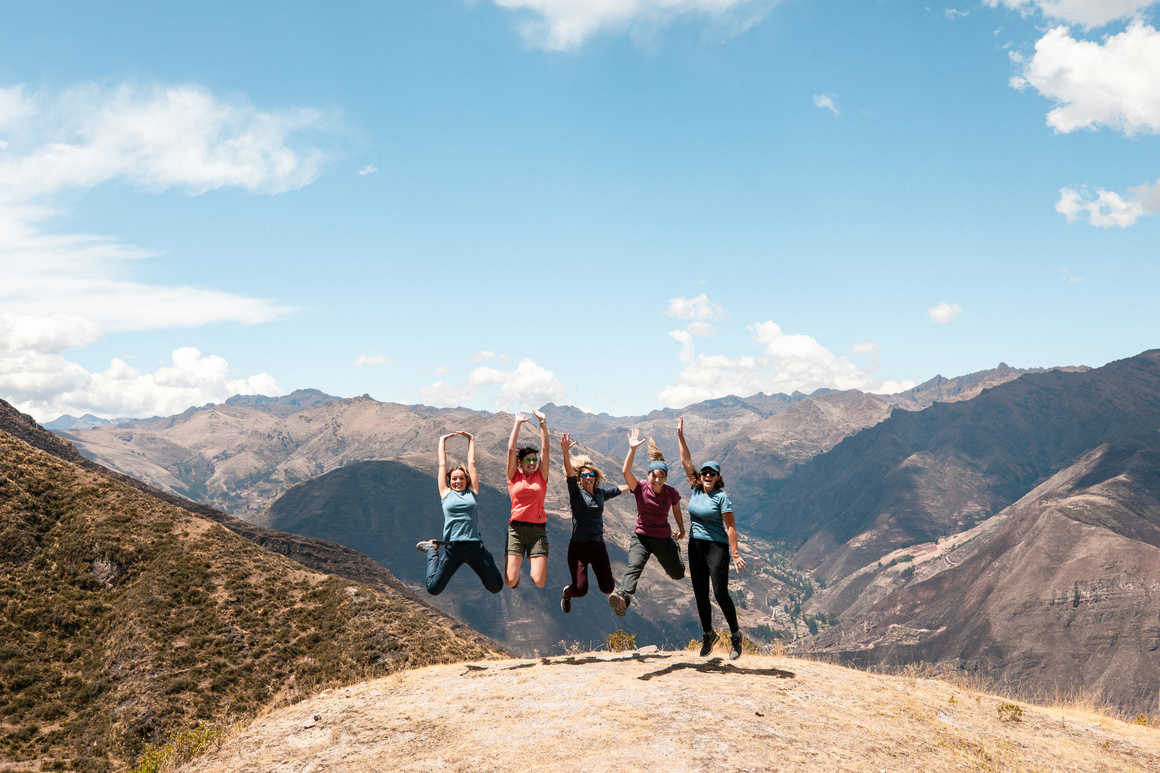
503, 411, 549, 587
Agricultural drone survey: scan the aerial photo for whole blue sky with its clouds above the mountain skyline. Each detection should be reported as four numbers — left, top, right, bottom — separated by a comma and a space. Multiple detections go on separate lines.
0, 0, 1160, 420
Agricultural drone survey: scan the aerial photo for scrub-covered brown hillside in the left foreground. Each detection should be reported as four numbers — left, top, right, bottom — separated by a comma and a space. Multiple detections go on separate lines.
0, 415, 495, 771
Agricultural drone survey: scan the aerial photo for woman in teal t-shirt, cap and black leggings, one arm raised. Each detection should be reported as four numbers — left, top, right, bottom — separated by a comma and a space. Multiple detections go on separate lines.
676, 417, 745, 659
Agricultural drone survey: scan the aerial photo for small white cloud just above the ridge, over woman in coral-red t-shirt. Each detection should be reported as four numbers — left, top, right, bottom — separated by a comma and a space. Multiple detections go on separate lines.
420, 359, 565, 411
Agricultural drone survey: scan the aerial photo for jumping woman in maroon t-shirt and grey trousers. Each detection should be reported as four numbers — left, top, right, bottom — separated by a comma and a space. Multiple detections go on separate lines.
608, 429, 684, 615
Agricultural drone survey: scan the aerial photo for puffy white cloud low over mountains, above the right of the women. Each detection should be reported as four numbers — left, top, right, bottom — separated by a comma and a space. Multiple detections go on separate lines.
659, 322, 913, 407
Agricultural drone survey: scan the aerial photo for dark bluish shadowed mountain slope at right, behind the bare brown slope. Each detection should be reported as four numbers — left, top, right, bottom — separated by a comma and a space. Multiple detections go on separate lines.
754, 351, 1160, 581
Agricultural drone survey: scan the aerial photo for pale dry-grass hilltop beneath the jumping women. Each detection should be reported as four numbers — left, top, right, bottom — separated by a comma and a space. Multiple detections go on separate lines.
183, 652, 1160, 773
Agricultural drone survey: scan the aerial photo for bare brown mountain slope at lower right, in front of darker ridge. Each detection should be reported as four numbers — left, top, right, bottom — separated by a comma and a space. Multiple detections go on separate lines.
807, 436, 1160, 714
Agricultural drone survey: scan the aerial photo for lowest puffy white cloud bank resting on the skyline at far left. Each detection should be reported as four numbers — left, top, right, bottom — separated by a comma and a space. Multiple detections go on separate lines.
0, 347, 282, 421
